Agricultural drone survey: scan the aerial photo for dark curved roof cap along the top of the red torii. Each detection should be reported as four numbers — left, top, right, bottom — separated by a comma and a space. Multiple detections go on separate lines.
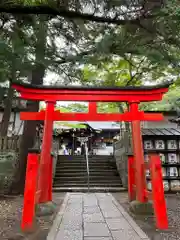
13, 81, 173, 91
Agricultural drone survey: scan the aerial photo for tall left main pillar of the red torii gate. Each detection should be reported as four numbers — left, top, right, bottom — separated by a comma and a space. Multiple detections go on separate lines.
39, 102, 55, 203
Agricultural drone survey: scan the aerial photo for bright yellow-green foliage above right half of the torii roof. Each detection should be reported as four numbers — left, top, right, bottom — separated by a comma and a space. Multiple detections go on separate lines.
80, 54, 172, 106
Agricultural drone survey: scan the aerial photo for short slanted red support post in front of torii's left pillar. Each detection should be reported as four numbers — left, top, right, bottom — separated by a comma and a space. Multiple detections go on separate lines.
21, 153, 39, 231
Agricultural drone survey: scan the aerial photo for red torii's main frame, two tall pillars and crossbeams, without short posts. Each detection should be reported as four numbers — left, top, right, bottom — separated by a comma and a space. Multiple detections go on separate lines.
12, 82, 171, 231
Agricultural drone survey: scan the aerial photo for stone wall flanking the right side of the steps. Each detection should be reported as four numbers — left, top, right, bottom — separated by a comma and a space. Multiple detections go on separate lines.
114, 132, 132, 188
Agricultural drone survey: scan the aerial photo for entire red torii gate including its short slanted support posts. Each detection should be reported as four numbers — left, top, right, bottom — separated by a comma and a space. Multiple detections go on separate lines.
12, 82, 171, 230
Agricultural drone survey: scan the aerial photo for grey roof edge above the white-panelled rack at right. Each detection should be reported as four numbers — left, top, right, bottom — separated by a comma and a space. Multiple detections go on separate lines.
142, 128, 180, 136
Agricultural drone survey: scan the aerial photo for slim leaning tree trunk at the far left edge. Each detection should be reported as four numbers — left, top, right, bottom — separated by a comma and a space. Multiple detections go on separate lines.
0, 84, 14, 137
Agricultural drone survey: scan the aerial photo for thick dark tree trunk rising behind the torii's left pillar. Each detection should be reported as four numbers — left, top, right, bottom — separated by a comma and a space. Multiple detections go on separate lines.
13, 16, 47, 193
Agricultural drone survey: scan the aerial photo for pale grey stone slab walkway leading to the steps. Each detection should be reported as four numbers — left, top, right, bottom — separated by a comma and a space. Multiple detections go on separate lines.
47, 193, 149, 240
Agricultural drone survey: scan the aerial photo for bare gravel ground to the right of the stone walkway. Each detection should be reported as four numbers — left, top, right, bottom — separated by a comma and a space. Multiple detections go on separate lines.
113, 193, 180, 240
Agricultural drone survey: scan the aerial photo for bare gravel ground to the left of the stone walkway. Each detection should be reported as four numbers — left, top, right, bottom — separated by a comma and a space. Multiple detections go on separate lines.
0, 193, 65, 240
